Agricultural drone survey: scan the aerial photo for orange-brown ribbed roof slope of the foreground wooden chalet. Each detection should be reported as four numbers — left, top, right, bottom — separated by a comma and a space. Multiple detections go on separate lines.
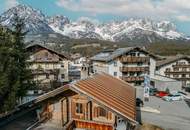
71, 74, 136, 122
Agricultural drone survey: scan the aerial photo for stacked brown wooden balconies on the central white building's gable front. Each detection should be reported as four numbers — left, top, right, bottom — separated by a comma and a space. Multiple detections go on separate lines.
120, 54, 150, 85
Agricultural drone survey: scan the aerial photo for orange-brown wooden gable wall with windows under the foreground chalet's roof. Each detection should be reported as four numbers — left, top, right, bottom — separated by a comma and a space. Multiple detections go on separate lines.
68, 95, 115, 130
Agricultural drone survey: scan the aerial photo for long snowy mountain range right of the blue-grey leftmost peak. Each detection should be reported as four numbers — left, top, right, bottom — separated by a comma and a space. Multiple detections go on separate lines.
51, 19, 185, 42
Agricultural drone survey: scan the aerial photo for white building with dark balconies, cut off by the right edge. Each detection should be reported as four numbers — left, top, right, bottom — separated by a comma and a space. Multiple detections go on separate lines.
156, 55, 190, 87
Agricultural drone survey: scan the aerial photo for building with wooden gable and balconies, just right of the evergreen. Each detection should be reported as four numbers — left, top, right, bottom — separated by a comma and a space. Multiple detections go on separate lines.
27, 44, 69, 90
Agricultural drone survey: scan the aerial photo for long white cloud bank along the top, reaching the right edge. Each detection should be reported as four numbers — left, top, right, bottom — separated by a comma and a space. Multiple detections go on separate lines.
56, 0, 190, 20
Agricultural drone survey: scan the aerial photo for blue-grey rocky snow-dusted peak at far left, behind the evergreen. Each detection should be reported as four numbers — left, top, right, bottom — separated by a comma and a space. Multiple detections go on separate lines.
0, 5, 54, 34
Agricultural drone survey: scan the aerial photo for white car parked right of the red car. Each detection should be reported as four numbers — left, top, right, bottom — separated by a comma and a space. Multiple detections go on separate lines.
162, 94, 184, 102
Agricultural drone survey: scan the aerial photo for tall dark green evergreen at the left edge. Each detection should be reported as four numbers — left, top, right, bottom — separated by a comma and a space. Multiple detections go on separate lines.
0, 15, 33, 113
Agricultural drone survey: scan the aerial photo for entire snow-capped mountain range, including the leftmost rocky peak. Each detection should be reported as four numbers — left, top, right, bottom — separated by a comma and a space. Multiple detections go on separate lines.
0, 5, 187, 43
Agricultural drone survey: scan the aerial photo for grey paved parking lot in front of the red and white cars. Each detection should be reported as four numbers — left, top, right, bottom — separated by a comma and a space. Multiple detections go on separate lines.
137, 87, 190, 130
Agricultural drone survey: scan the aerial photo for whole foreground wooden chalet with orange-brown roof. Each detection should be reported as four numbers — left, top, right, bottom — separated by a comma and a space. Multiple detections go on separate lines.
34, 74, 136, 130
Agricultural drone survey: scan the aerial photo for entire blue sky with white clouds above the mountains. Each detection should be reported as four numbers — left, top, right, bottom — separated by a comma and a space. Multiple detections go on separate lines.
0, 0, 190, 36
